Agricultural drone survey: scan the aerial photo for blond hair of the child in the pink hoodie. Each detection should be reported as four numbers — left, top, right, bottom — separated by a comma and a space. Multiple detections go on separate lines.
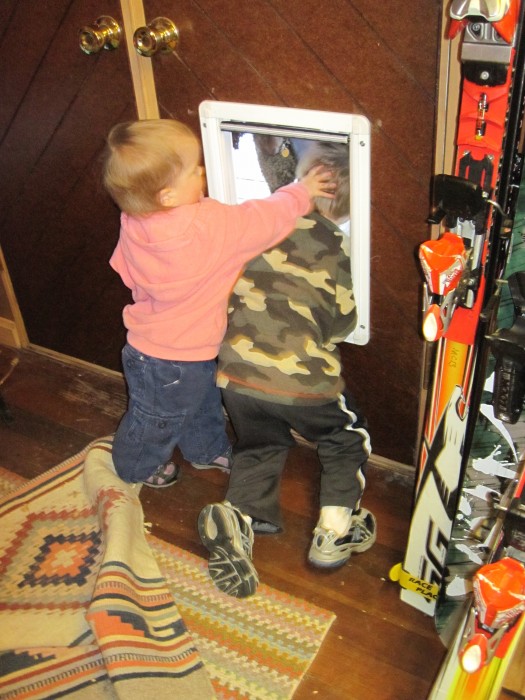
103, 119, 199, 216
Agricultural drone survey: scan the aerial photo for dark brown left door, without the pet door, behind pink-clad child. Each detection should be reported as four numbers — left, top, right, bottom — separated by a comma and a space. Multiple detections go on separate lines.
0, 0, 136, 370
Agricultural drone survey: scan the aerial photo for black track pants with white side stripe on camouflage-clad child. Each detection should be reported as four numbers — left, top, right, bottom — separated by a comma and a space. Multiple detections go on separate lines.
222, 389, 370, 526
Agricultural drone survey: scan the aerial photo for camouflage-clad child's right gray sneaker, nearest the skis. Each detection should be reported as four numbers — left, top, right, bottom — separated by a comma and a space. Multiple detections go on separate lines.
308, 508, 377, 569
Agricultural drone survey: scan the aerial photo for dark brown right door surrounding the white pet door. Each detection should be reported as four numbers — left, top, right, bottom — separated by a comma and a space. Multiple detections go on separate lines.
151, 0, 441, 464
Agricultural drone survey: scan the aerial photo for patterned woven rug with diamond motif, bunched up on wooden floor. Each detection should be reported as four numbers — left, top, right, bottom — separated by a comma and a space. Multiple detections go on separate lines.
0, 438, 334, 700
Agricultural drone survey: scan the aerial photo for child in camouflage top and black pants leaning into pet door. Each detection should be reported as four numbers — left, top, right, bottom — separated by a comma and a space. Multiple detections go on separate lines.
198, 143, 376, 597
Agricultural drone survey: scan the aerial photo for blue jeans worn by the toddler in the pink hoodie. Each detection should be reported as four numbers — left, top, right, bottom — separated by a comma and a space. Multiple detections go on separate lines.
113, 344, 230, 482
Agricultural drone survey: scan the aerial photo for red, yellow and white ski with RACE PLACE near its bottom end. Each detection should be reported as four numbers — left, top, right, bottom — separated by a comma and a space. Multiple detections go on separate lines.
390, 0, 525, 615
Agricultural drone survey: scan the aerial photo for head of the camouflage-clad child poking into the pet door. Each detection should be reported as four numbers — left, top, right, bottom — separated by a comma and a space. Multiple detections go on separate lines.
296, 141, 350, 222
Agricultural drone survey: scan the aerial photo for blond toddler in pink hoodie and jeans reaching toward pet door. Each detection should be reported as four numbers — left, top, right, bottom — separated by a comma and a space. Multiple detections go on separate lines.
104, 119, 333, 488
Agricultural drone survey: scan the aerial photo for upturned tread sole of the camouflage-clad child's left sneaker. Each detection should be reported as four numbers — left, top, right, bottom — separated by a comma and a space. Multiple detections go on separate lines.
197, 504, 259, 598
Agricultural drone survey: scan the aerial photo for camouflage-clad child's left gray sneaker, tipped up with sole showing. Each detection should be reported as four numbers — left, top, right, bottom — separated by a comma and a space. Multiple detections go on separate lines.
198, 501, 259, 598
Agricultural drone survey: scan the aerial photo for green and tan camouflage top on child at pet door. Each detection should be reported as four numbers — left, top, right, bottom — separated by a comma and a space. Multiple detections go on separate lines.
217, 213, 357, 405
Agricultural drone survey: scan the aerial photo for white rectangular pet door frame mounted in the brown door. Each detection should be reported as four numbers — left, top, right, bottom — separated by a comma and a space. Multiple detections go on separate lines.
199, 100, 370, 345
